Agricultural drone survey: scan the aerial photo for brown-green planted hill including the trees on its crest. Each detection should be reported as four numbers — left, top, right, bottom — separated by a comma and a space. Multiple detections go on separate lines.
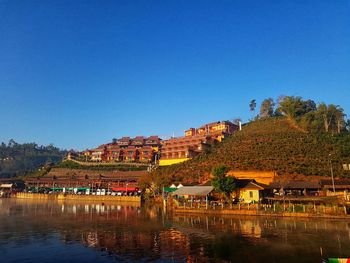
144, 96, 350, 188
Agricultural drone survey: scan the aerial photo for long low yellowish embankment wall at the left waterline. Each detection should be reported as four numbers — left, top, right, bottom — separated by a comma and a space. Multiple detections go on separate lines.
12, 193, 141, 204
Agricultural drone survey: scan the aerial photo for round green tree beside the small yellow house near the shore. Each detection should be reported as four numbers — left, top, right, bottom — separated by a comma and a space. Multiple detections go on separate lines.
212, 166, 237, 200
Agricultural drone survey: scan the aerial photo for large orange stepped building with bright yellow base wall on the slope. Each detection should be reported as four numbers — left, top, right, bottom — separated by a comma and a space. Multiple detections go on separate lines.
159, 121, 239, 166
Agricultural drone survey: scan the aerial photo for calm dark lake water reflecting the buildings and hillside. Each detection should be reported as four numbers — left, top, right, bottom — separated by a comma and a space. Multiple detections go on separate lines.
0, 199, 350, 263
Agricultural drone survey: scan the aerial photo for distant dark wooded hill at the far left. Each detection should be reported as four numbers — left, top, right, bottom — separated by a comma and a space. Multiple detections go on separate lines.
0, 140, 67, 178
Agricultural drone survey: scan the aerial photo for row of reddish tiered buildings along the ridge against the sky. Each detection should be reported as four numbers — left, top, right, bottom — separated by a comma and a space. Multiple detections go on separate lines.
68, 121, 239, 166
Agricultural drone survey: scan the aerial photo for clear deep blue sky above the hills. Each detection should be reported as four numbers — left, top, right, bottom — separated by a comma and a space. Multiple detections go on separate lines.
0, 0, 350, 149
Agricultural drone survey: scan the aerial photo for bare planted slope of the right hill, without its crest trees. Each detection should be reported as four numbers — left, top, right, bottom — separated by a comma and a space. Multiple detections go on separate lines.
154, 117, 350, 186
